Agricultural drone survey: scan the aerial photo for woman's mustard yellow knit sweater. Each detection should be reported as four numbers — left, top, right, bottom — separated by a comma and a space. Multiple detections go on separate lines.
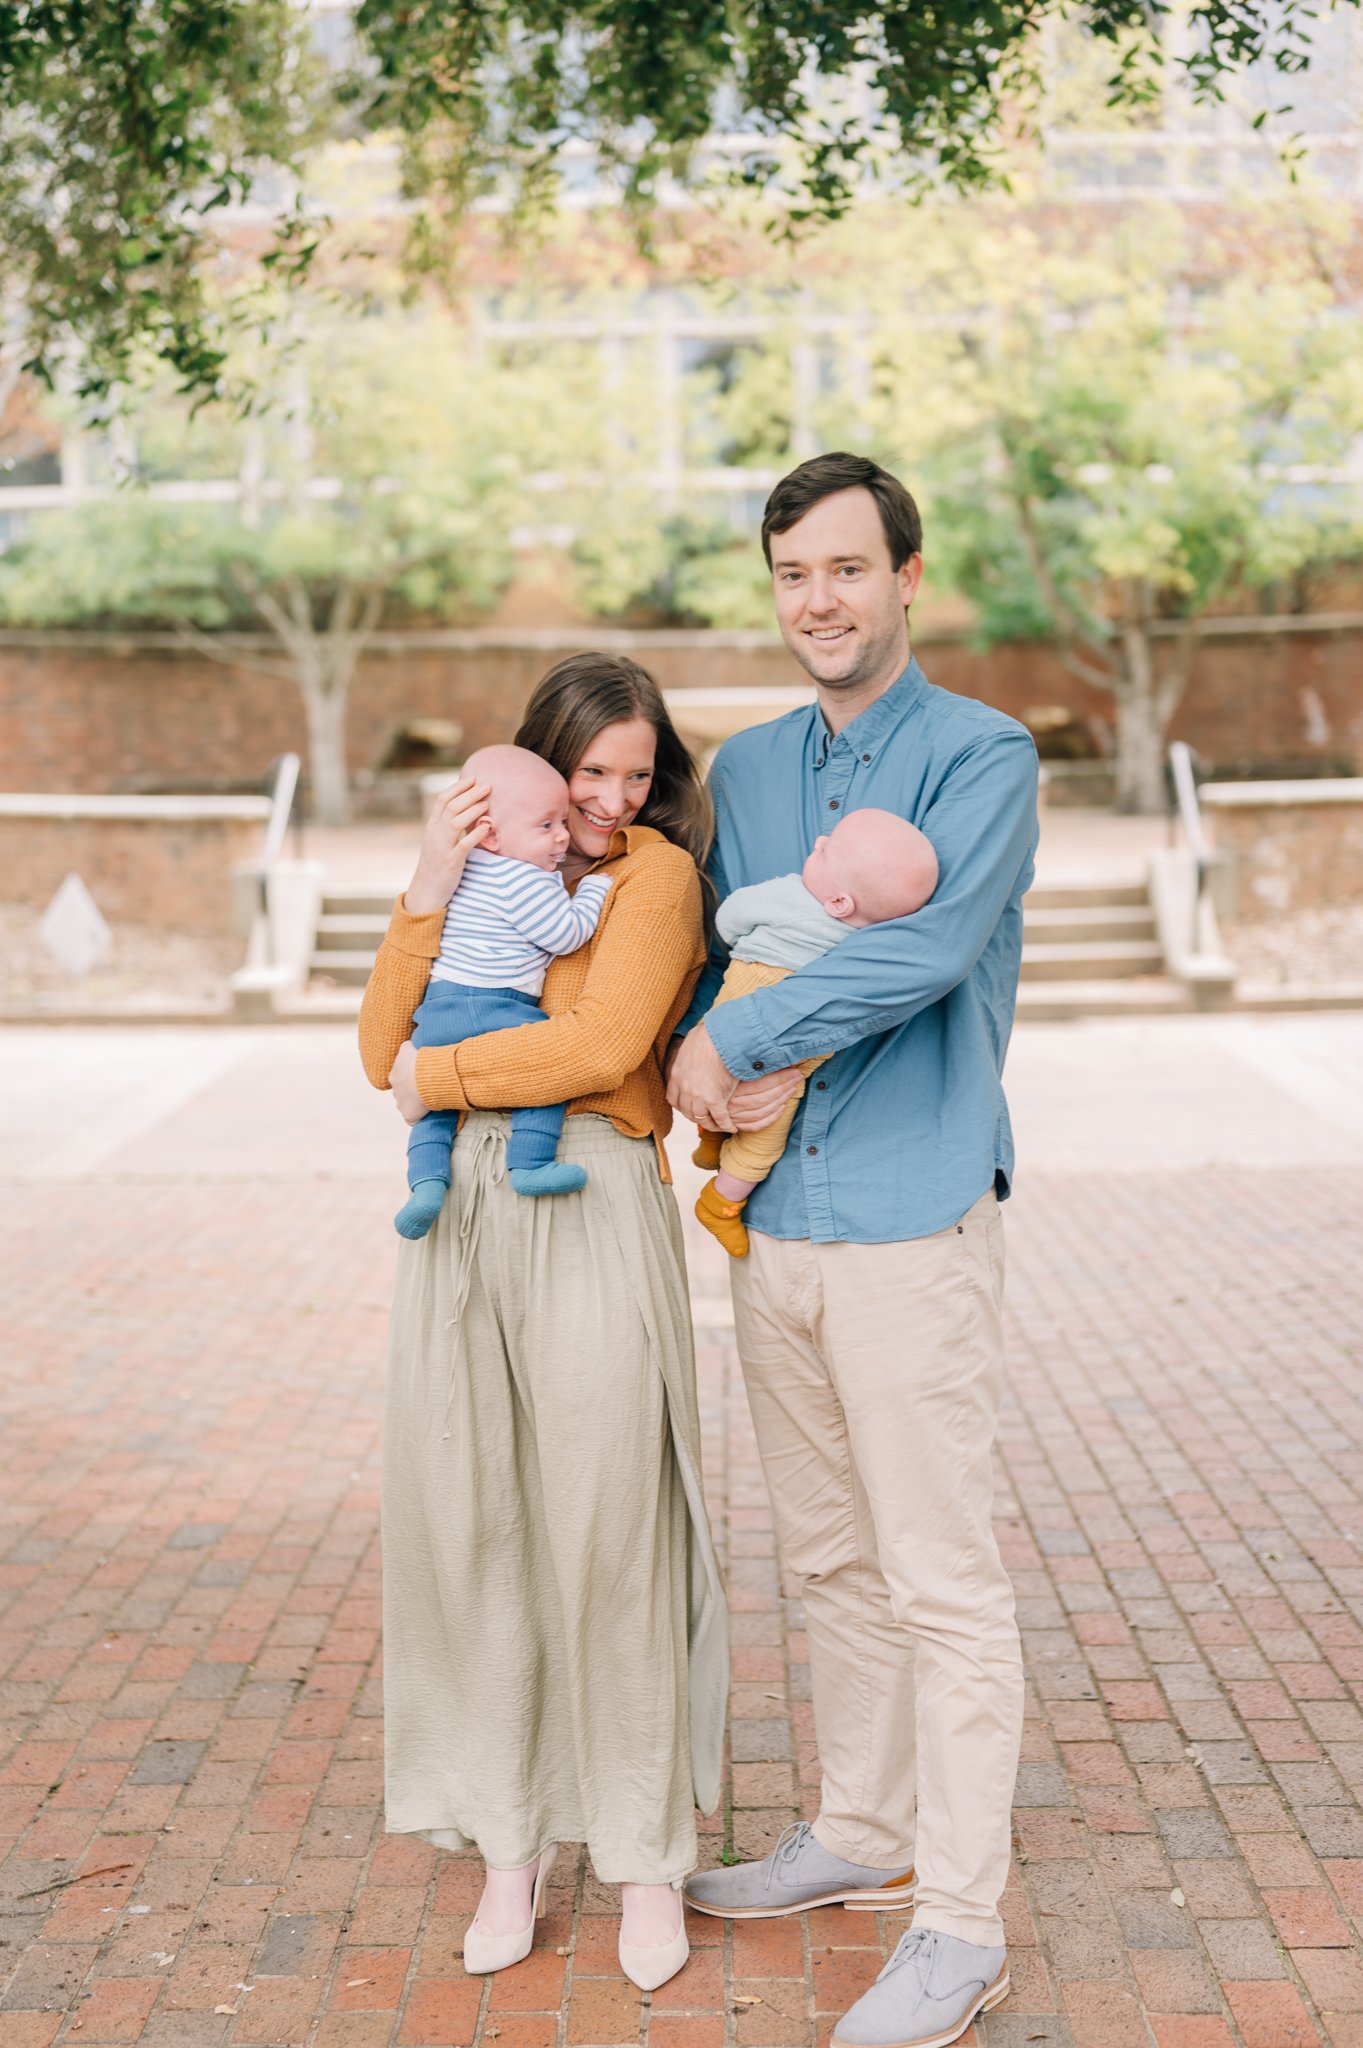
360, 825, 704, 1180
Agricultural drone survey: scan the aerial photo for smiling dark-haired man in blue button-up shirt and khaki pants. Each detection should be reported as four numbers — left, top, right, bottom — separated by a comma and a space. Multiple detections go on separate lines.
669, 455, 1038, 2048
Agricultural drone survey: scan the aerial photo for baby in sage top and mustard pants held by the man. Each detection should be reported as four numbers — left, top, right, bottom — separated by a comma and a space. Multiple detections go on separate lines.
694, 809, 937, 1260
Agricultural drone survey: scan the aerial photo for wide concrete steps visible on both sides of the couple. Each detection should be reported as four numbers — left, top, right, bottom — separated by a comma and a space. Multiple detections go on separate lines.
305, 874, 1191, 1022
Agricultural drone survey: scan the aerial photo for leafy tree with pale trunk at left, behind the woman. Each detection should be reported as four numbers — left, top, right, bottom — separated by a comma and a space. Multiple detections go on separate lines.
0, 299, 575, 823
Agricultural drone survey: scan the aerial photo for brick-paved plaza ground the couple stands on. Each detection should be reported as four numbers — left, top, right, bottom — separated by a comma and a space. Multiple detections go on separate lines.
0, 1020, 1363, 2048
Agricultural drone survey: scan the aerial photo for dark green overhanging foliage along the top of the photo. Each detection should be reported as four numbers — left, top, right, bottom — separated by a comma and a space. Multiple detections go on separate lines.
0, 0, 1359, 395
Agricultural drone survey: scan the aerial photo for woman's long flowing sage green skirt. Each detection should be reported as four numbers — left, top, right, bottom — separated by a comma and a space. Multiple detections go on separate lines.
383, 1110, 729, 1884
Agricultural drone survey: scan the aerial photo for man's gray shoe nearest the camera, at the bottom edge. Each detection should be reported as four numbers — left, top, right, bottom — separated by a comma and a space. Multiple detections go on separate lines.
833, 1927, 1009, 2048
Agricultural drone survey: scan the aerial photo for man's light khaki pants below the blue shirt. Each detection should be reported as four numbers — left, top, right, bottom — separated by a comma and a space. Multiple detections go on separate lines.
733, 1192, 1023, 1944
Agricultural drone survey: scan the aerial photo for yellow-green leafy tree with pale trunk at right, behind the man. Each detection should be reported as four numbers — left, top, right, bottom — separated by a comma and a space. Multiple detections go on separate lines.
556, 195, 1363, 809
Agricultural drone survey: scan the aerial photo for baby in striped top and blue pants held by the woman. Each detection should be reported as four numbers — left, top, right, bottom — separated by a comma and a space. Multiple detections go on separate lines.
393, 748, 610, 1237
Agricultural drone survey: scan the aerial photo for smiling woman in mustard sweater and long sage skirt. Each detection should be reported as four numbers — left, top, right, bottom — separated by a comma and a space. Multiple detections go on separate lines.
360, 653, 727, 1991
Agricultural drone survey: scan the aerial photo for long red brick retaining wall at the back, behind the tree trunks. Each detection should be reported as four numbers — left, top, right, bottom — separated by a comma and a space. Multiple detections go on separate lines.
0, 629, 1363, 791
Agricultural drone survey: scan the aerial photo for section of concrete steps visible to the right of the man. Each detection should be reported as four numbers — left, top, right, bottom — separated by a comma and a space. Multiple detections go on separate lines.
1017, 874, 1191, 1022
